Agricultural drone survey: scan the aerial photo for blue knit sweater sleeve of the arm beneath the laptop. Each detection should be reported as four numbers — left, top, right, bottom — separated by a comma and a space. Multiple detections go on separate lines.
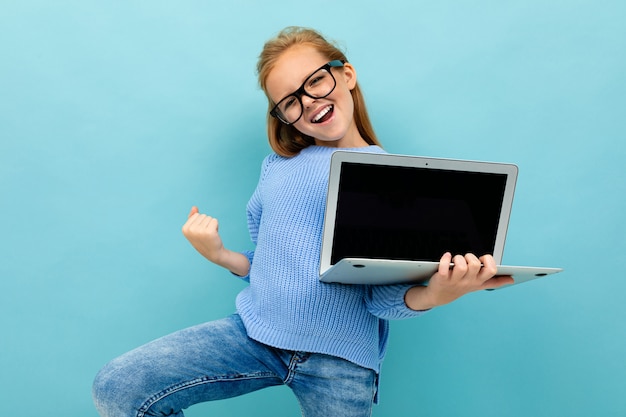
366, 284, 428, 320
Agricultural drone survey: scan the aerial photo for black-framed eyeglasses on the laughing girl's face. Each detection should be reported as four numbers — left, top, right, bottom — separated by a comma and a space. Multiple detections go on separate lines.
270, 59, 345, 125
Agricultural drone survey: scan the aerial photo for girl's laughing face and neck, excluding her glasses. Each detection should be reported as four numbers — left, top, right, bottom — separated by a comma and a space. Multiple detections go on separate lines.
266, 44, 367, 148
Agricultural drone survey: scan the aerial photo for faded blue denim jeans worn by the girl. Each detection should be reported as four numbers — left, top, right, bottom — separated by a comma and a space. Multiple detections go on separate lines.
93, 314, 377, 417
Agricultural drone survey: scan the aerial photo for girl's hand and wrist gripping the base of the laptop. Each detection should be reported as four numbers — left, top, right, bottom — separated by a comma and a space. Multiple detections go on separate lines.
405, 252, 513, 310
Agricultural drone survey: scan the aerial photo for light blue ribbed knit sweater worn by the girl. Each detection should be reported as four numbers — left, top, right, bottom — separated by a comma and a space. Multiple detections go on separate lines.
237, 146, 422, 372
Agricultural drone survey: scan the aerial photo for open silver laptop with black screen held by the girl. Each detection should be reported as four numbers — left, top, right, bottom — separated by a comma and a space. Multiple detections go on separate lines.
320, 151, 562, 288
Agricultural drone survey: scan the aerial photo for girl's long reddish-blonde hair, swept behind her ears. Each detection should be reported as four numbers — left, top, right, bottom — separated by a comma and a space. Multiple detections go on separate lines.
257, 26, 380, 157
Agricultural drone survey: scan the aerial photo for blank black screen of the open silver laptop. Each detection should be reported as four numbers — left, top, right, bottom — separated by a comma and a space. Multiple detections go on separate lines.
331, 162, 507, 264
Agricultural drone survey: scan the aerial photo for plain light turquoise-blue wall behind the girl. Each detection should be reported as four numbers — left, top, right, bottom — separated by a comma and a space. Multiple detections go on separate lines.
0, 0, 626, 417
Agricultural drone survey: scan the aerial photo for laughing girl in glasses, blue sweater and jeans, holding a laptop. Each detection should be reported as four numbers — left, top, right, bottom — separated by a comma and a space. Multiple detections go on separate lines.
93, 28, 512, 417
